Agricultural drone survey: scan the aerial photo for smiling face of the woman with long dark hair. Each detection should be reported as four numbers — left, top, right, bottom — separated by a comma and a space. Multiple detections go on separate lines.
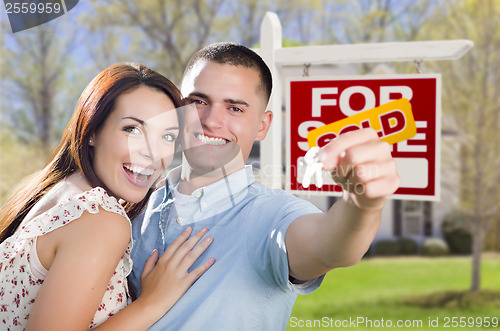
90, 86, 179, 203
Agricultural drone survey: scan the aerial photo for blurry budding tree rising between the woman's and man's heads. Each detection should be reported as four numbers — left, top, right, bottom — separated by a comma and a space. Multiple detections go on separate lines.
81, 0, 227, 83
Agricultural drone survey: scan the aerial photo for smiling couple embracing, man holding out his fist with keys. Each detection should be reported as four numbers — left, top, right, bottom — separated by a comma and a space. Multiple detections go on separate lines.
0, 43, 399, 330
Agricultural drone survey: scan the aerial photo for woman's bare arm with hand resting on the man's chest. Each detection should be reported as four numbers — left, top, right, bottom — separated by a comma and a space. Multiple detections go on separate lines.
26, 210, 211, 330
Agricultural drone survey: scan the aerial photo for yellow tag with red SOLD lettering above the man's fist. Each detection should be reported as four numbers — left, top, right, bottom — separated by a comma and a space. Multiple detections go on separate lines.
307, 98, 417, 148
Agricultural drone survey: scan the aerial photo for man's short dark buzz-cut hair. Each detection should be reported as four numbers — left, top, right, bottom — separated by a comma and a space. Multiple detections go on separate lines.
184, 42, 273, 101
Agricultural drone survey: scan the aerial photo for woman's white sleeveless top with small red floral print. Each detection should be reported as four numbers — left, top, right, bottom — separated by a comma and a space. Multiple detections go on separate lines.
0, 187, 132, 330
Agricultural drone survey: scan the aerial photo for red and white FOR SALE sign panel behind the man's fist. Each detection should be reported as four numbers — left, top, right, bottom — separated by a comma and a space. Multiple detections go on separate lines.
286, 74, 441, 201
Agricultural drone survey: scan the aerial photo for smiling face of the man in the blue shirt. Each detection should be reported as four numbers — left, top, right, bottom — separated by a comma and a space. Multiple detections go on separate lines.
181, 61, 272, 171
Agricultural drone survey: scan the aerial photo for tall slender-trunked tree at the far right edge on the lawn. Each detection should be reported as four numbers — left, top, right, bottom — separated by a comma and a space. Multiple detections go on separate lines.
427, 0, 500, 291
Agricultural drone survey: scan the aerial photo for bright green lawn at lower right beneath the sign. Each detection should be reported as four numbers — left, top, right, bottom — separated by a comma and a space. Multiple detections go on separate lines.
287, 255, 500, 331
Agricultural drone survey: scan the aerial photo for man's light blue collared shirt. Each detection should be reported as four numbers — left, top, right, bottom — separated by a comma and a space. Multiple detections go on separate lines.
129, 166, 323, 331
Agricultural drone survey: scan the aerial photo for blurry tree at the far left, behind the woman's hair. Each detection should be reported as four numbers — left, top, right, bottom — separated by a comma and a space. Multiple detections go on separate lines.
1, 21, 77, 151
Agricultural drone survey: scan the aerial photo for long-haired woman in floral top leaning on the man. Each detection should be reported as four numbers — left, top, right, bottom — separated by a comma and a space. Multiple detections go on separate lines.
0, 64, 214, 330
